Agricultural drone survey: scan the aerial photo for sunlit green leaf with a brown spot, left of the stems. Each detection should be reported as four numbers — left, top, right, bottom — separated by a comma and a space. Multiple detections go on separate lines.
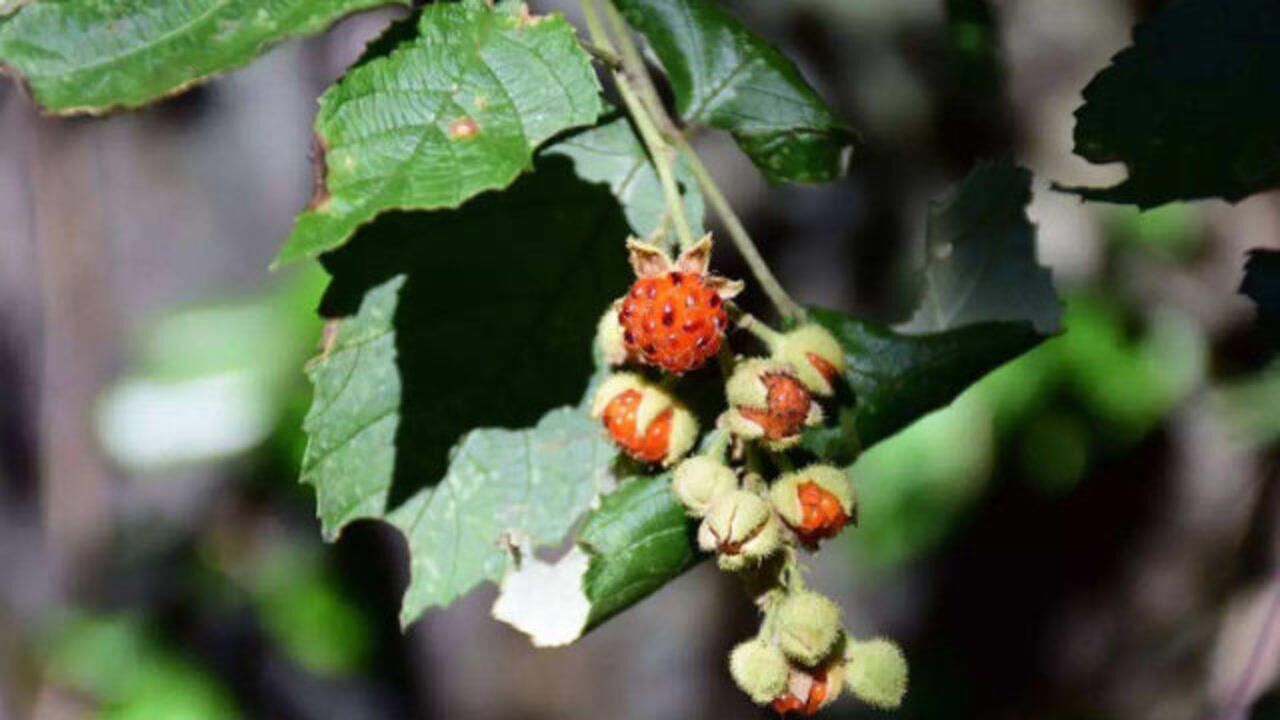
276, 0, 602, 263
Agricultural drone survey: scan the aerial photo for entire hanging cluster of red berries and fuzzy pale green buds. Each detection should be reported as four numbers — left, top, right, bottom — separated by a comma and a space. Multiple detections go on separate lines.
591, 236, 906, 715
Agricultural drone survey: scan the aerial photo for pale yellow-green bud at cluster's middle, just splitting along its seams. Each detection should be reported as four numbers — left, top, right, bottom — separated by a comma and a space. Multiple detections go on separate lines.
698, 489, 781, 571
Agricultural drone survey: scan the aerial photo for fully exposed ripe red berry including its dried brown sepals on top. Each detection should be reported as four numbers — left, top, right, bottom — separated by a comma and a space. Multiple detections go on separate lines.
618, 236, 741, 374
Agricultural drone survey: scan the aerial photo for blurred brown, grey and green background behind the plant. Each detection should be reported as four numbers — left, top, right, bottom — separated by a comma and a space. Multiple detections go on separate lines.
0, 0, 1280, 720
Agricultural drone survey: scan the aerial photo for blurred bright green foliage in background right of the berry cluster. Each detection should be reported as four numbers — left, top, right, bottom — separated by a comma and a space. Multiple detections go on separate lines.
844, 291, 1207, 568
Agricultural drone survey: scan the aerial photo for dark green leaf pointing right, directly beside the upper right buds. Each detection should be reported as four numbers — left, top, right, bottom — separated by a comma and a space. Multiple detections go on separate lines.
804, 307, 1046, 464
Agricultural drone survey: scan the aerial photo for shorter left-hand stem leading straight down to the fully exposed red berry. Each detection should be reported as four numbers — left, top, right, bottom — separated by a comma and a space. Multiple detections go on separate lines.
580, 0, 695, 250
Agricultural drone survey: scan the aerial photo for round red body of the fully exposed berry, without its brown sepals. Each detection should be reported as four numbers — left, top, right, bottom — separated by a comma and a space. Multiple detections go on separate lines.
618, 270, 728, 374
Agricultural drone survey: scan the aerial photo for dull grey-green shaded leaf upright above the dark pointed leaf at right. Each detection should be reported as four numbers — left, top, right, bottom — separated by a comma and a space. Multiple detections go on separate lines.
899, 163, 1062, 333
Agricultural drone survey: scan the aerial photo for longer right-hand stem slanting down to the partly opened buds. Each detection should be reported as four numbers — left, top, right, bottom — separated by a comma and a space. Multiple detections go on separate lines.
584, 0, 804, 320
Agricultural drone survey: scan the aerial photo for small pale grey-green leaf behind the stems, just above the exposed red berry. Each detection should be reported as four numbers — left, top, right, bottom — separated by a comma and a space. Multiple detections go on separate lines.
543, 118, 703, 237
